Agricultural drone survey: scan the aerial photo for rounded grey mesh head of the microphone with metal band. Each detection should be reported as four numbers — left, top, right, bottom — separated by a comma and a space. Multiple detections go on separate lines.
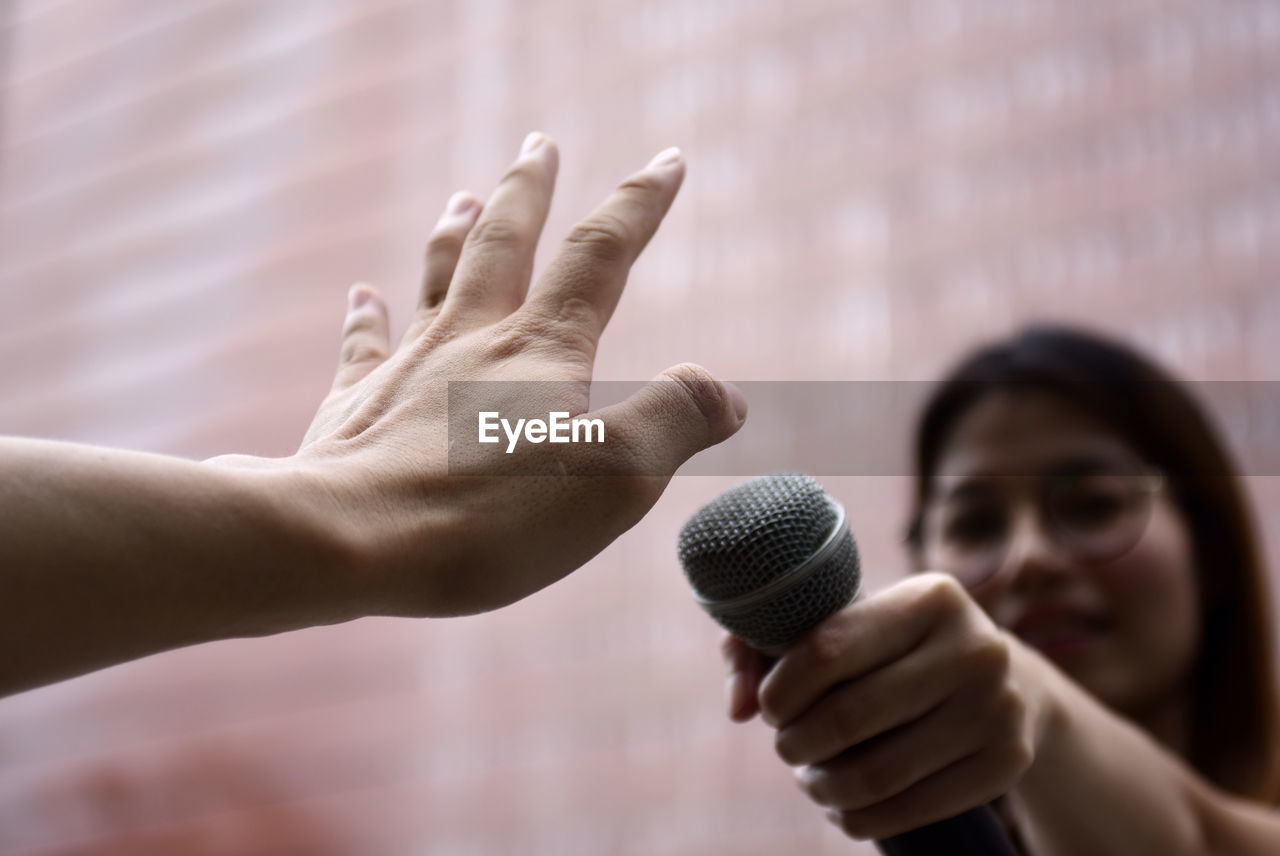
678, 473, 859, 654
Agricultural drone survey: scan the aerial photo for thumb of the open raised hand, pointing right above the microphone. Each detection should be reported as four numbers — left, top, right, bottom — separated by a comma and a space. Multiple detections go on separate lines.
596, 362, 746, 476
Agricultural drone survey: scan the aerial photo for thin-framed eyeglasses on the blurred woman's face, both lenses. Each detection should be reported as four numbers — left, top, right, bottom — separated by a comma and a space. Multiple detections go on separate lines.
923, 472, 1165, 589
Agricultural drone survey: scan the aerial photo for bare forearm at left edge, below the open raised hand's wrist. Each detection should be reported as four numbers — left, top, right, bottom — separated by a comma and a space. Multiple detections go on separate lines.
0, 439, 355, 694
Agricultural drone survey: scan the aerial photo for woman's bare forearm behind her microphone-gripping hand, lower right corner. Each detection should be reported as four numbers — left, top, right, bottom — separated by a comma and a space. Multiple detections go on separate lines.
1010, 651, 1280, 856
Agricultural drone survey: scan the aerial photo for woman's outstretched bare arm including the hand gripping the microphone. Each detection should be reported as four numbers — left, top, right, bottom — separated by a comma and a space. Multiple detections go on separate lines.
724, 575, 1280, 856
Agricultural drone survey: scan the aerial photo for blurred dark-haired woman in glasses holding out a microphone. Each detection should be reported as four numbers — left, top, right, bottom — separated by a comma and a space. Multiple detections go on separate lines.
724, 328, 1280, 856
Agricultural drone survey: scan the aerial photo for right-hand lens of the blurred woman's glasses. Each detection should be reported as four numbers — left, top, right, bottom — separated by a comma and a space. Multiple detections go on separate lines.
1046, 472, 1152, 562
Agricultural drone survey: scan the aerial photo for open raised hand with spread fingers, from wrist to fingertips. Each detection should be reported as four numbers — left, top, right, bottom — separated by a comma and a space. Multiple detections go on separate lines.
280, 133, 745, 614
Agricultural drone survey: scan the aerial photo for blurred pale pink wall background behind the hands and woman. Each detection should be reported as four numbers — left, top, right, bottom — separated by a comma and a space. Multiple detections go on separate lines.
0, 0, 1280, 856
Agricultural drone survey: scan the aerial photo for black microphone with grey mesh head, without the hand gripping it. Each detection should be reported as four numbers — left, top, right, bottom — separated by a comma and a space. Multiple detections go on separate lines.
678, 473, 1018, 856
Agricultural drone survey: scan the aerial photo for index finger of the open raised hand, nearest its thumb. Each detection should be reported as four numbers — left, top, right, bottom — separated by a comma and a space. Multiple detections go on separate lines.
524, 148, 685, 347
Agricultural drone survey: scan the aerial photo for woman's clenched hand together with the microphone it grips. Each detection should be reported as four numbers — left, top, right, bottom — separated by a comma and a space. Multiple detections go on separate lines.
680, 475, 1047, 856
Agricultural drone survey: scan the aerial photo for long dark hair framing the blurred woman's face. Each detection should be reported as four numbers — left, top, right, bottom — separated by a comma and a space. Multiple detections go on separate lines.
908, 326, 1280, 804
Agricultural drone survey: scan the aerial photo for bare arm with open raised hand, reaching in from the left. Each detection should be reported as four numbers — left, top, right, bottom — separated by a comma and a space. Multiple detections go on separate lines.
0, 134, 746, 694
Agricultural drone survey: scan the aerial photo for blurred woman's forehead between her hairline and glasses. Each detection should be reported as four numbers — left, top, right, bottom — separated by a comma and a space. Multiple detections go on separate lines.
937, 392, 1139, 487
